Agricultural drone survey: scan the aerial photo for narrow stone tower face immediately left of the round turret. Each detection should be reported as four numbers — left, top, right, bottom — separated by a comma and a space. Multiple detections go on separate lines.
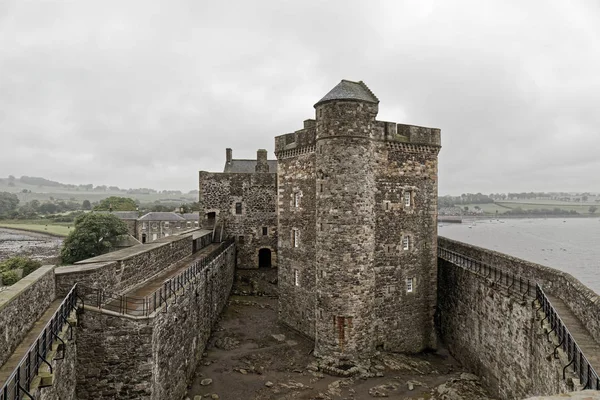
277, 121, 317, 338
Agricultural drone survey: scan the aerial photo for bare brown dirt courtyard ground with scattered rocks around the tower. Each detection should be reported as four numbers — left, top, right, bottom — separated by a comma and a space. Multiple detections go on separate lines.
188, 272, 492, 400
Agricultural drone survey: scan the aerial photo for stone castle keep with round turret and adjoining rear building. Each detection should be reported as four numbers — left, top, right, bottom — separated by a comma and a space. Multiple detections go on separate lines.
200, 80, 440, 362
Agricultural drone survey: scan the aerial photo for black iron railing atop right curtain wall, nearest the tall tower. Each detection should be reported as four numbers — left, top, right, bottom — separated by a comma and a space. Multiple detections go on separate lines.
438, 246, 535, 298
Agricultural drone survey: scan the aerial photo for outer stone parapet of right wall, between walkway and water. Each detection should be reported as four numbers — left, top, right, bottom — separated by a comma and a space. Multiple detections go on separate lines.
438, 237, 600, 342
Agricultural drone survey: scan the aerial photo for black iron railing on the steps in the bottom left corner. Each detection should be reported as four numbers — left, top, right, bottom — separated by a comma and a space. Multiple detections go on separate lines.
0, 284, 78, 400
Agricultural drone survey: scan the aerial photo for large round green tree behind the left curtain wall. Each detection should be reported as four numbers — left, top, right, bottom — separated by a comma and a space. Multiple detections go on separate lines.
60, 213, 127, 264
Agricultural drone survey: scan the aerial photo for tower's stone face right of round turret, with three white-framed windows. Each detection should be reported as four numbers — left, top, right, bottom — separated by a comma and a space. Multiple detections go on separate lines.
374, 138, 439, 352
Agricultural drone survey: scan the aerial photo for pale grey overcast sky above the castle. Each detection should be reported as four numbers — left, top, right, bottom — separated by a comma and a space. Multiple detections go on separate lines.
0, 0, 600, 194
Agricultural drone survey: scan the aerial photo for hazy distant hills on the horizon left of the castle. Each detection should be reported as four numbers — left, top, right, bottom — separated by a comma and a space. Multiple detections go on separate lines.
0, 175, 198, 203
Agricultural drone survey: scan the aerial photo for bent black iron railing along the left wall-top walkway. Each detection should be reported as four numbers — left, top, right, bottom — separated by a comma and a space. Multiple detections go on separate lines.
81, 238, 235, 318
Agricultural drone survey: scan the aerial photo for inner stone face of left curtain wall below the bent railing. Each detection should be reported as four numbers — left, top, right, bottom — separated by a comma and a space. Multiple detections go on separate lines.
77, 245, 235, 400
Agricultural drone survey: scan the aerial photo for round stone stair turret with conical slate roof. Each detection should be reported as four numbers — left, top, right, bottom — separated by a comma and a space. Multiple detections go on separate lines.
315, 81, 379, 359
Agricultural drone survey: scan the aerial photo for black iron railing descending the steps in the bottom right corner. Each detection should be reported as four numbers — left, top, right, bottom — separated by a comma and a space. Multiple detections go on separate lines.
535, 285, 600, 390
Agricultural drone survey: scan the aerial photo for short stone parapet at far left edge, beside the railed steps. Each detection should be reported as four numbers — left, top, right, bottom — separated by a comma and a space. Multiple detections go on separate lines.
0, 265, 56, 365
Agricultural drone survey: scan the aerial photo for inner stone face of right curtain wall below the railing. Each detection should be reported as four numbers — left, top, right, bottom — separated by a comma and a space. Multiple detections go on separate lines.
436, 242, 584, 399
